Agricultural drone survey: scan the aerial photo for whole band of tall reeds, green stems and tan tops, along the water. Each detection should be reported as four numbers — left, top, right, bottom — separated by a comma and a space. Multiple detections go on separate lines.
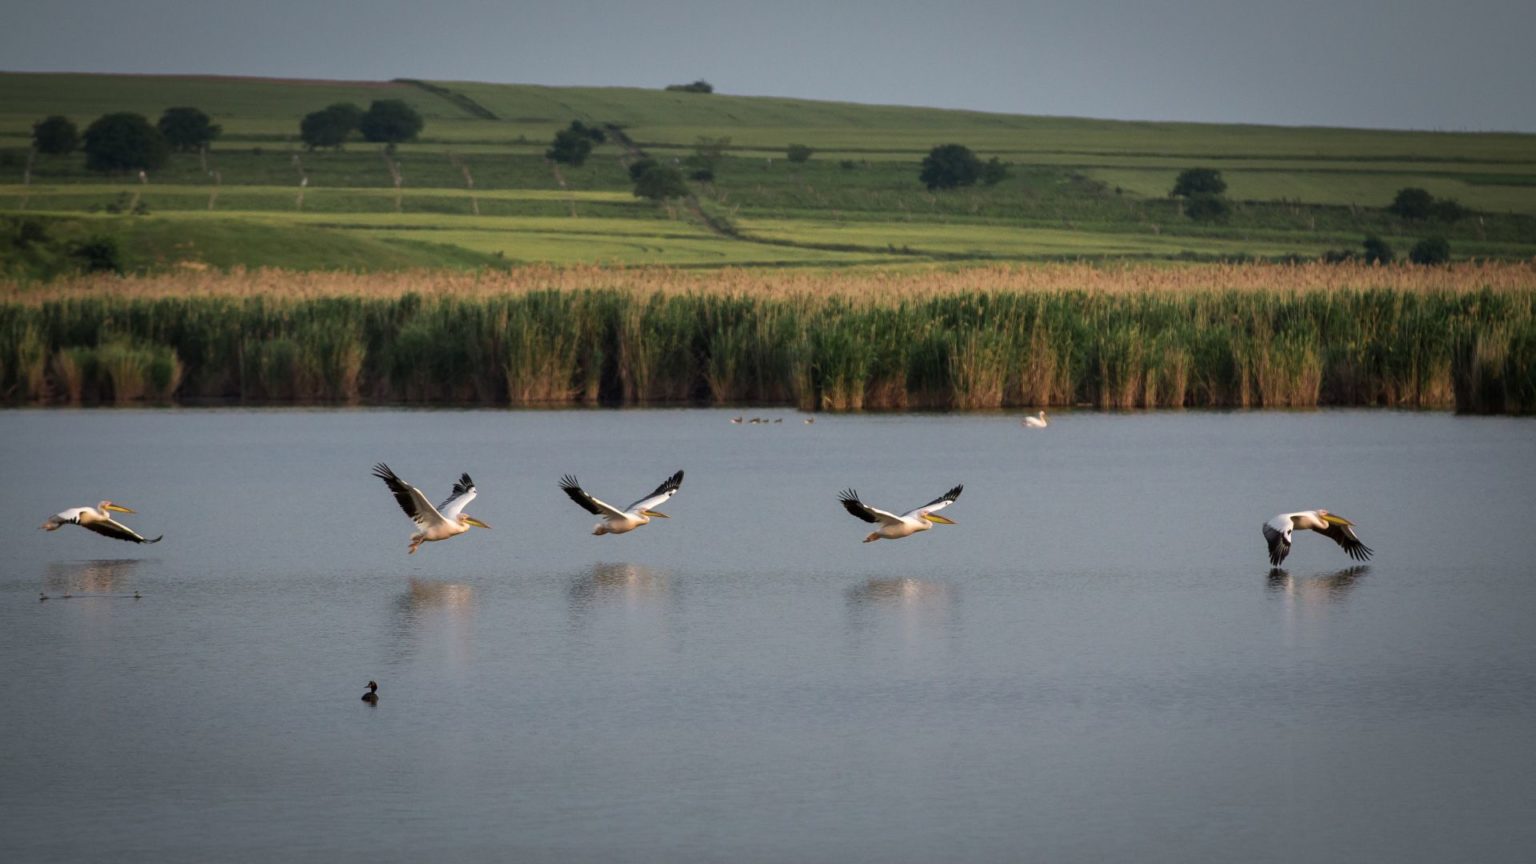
0, 261, 1536, 414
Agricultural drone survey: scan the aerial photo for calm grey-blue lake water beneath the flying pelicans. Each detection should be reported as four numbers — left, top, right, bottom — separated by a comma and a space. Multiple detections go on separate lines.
0, 410, 1536, 864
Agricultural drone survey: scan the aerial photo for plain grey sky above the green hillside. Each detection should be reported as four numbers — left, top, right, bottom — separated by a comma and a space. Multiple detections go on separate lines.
0, 0, 1536, 132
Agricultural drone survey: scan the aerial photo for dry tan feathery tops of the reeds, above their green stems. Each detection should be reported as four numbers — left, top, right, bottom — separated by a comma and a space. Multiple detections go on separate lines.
9, 261, 1536, 304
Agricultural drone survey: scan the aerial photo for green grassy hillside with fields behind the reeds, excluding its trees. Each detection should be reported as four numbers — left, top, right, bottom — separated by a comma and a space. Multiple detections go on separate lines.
0, 74, 1536, 275
